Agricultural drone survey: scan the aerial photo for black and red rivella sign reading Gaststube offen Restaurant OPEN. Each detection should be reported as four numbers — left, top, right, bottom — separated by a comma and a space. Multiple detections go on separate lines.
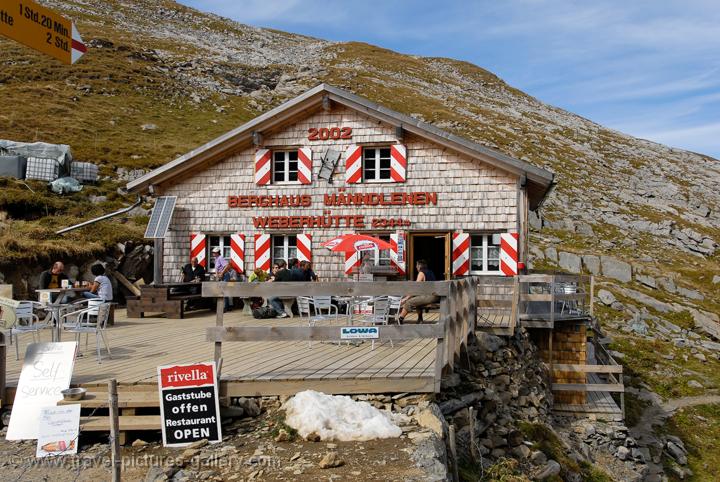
158, 362, 222, 447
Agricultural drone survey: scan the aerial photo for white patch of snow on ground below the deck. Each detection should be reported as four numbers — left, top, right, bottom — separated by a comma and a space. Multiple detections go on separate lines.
283, 390, 402, 442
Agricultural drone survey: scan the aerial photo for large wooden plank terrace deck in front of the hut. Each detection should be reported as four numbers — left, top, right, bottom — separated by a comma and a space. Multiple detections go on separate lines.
7, 310, 438, 396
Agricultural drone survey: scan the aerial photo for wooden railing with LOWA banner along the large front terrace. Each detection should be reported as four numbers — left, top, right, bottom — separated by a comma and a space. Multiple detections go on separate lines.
202, 278, 477, 391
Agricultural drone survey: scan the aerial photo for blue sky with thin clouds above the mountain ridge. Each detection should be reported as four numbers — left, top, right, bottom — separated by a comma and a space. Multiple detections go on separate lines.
181, 0, 720, 158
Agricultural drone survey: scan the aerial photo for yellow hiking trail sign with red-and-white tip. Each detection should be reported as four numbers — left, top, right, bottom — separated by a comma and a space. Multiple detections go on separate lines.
0, 0, 87, 64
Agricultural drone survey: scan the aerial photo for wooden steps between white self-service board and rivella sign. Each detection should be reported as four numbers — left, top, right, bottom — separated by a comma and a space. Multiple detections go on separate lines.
58, 385, 161, 445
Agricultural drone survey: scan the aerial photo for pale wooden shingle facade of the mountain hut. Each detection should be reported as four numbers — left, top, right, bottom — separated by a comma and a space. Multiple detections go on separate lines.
160, 107, 518, 279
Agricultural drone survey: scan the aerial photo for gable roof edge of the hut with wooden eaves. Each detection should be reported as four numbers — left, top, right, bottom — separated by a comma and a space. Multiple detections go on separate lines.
127, 84, 554, 209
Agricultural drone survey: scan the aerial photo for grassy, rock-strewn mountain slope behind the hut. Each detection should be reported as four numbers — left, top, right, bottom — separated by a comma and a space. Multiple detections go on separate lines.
0, 0, 720, 475
